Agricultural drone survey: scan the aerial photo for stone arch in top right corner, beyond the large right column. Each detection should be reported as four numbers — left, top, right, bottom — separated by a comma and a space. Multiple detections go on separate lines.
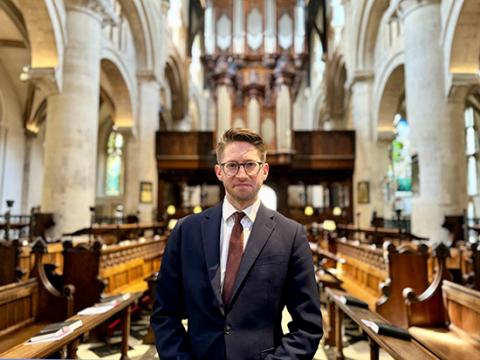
441, 0, 480, 93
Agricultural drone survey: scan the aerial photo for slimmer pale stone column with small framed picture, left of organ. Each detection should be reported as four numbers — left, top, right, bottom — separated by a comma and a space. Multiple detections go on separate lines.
125, 74, 160, 222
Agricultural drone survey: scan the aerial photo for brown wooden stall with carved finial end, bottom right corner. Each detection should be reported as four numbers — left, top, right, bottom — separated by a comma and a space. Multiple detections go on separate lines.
404, 244, 480, 360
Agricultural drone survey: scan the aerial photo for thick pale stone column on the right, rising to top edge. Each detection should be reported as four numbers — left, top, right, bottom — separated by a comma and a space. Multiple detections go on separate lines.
400, 0, 466, 242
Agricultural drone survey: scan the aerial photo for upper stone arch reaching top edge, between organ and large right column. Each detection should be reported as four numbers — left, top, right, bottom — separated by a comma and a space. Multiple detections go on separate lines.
354, 0, 388, 70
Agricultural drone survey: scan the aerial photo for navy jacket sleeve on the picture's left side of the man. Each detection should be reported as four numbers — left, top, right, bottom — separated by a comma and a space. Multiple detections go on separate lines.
150, 220, 193, 360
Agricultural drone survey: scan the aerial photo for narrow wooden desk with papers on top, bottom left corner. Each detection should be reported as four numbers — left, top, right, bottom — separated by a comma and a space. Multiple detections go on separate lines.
0, 293, 141, 359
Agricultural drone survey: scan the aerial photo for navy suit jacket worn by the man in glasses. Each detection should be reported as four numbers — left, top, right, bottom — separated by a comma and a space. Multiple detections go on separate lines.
151, 204, 323, 360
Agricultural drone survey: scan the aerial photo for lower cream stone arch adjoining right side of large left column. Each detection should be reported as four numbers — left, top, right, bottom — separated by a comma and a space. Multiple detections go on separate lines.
101, 47, 137, 128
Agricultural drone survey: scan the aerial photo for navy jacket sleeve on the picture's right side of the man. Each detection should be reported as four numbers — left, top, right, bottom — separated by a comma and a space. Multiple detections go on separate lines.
265, 224, 323, 360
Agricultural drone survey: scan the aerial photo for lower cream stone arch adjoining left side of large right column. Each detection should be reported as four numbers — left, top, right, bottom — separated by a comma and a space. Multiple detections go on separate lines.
372, 52, 405, 135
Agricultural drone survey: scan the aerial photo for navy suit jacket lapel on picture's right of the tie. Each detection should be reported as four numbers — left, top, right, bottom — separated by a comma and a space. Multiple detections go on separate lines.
232, 204, 275, 303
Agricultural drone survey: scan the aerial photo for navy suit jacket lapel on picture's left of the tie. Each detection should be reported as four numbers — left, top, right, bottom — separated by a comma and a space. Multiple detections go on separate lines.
202, 203, 223, 312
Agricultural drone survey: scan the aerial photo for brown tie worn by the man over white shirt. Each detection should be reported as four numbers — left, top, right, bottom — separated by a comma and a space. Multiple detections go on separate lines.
222, 211, 245, 305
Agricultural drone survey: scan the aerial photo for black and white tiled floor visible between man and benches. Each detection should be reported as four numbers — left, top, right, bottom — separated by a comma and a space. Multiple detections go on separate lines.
77, 311, 391, 360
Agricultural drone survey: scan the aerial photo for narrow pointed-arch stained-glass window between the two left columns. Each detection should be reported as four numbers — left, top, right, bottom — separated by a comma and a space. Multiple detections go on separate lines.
105, 129, 124, 196
